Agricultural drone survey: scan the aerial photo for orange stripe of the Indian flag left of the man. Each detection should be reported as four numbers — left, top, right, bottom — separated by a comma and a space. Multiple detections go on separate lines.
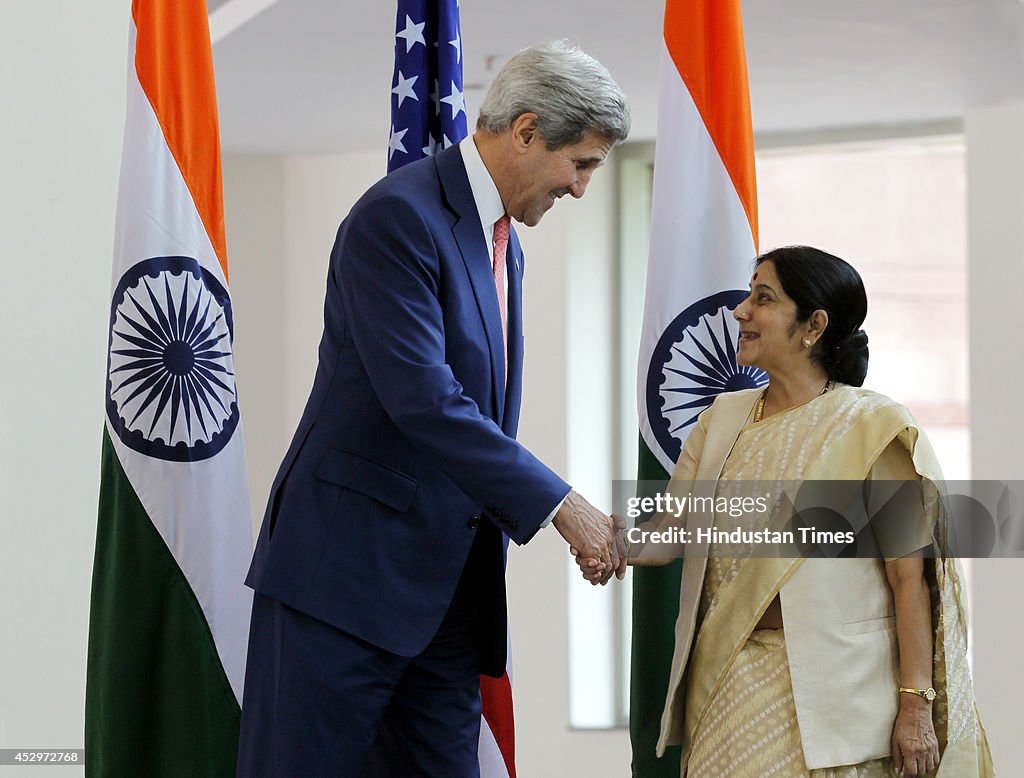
131, 0, 227, 278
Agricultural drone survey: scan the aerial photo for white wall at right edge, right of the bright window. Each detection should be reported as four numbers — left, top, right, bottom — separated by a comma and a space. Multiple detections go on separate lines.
965, 102, 1024, 775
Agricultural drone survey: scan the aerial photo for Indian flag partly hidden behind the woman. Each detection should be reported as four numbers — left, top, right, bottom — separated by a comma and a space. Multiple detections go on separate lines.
630, 0, 766, 778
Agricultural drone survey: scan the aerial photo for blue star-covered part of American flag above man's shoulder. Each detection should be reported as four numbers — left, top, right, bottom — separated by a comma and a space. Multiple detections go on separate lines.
387, 0, 467, 173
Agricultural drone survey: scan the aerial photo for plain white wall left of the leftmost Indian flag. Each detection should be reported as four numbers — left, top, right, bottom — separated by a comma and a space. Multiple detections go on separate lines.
0, 0, 128, 776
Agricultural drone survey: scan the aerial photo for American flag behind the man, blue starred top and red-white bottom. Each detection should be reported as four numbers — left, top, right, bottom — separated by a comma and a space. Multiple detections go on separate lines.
387, 6, 516, 778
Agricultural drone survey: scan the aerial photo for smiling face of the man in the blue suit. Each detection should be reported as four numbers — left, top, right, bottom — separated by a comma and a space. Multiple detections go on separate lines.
505, 126, 611, 227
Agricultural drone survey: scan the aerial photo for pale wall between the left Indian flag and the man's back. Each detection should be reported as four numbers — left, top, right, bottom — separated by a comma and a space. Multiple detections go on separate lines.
224, 153, 386, 530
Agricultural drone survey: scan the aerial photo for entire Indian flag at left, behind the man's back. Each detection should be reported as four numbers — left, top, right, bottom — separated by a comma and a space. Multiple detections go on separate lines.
85, 0, 252, 778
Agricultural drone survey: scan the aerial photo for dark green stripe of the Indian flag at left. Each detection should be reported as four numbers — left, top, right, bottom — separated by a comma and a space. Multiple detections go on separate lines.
85, 428, 241, 778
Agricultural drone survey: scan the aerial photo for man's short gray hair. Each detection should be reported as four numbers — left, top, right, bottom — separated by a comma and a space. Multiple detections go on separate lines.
476, 41, 630, 150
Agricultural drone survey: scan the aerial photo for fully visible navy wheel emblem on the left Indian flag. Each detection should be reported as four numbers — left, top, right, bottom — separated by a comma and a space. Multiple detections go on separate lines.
106, 257, 239, 462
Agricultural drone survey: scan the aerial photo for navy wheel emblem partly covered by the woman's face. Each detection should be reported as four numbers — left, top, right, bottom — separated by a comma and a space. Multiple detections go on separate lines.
646, 290, 768, 462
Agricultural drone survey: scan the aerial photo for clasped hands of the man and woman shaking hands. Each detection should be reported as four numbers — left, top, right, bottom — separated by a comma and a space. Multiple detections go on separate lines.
551, 490, 628, 587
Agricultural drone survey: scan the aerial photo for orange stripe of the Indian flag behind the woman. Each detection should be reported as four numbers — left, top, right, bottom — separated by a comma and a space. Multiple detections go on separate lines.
665, 0, 758, 249
